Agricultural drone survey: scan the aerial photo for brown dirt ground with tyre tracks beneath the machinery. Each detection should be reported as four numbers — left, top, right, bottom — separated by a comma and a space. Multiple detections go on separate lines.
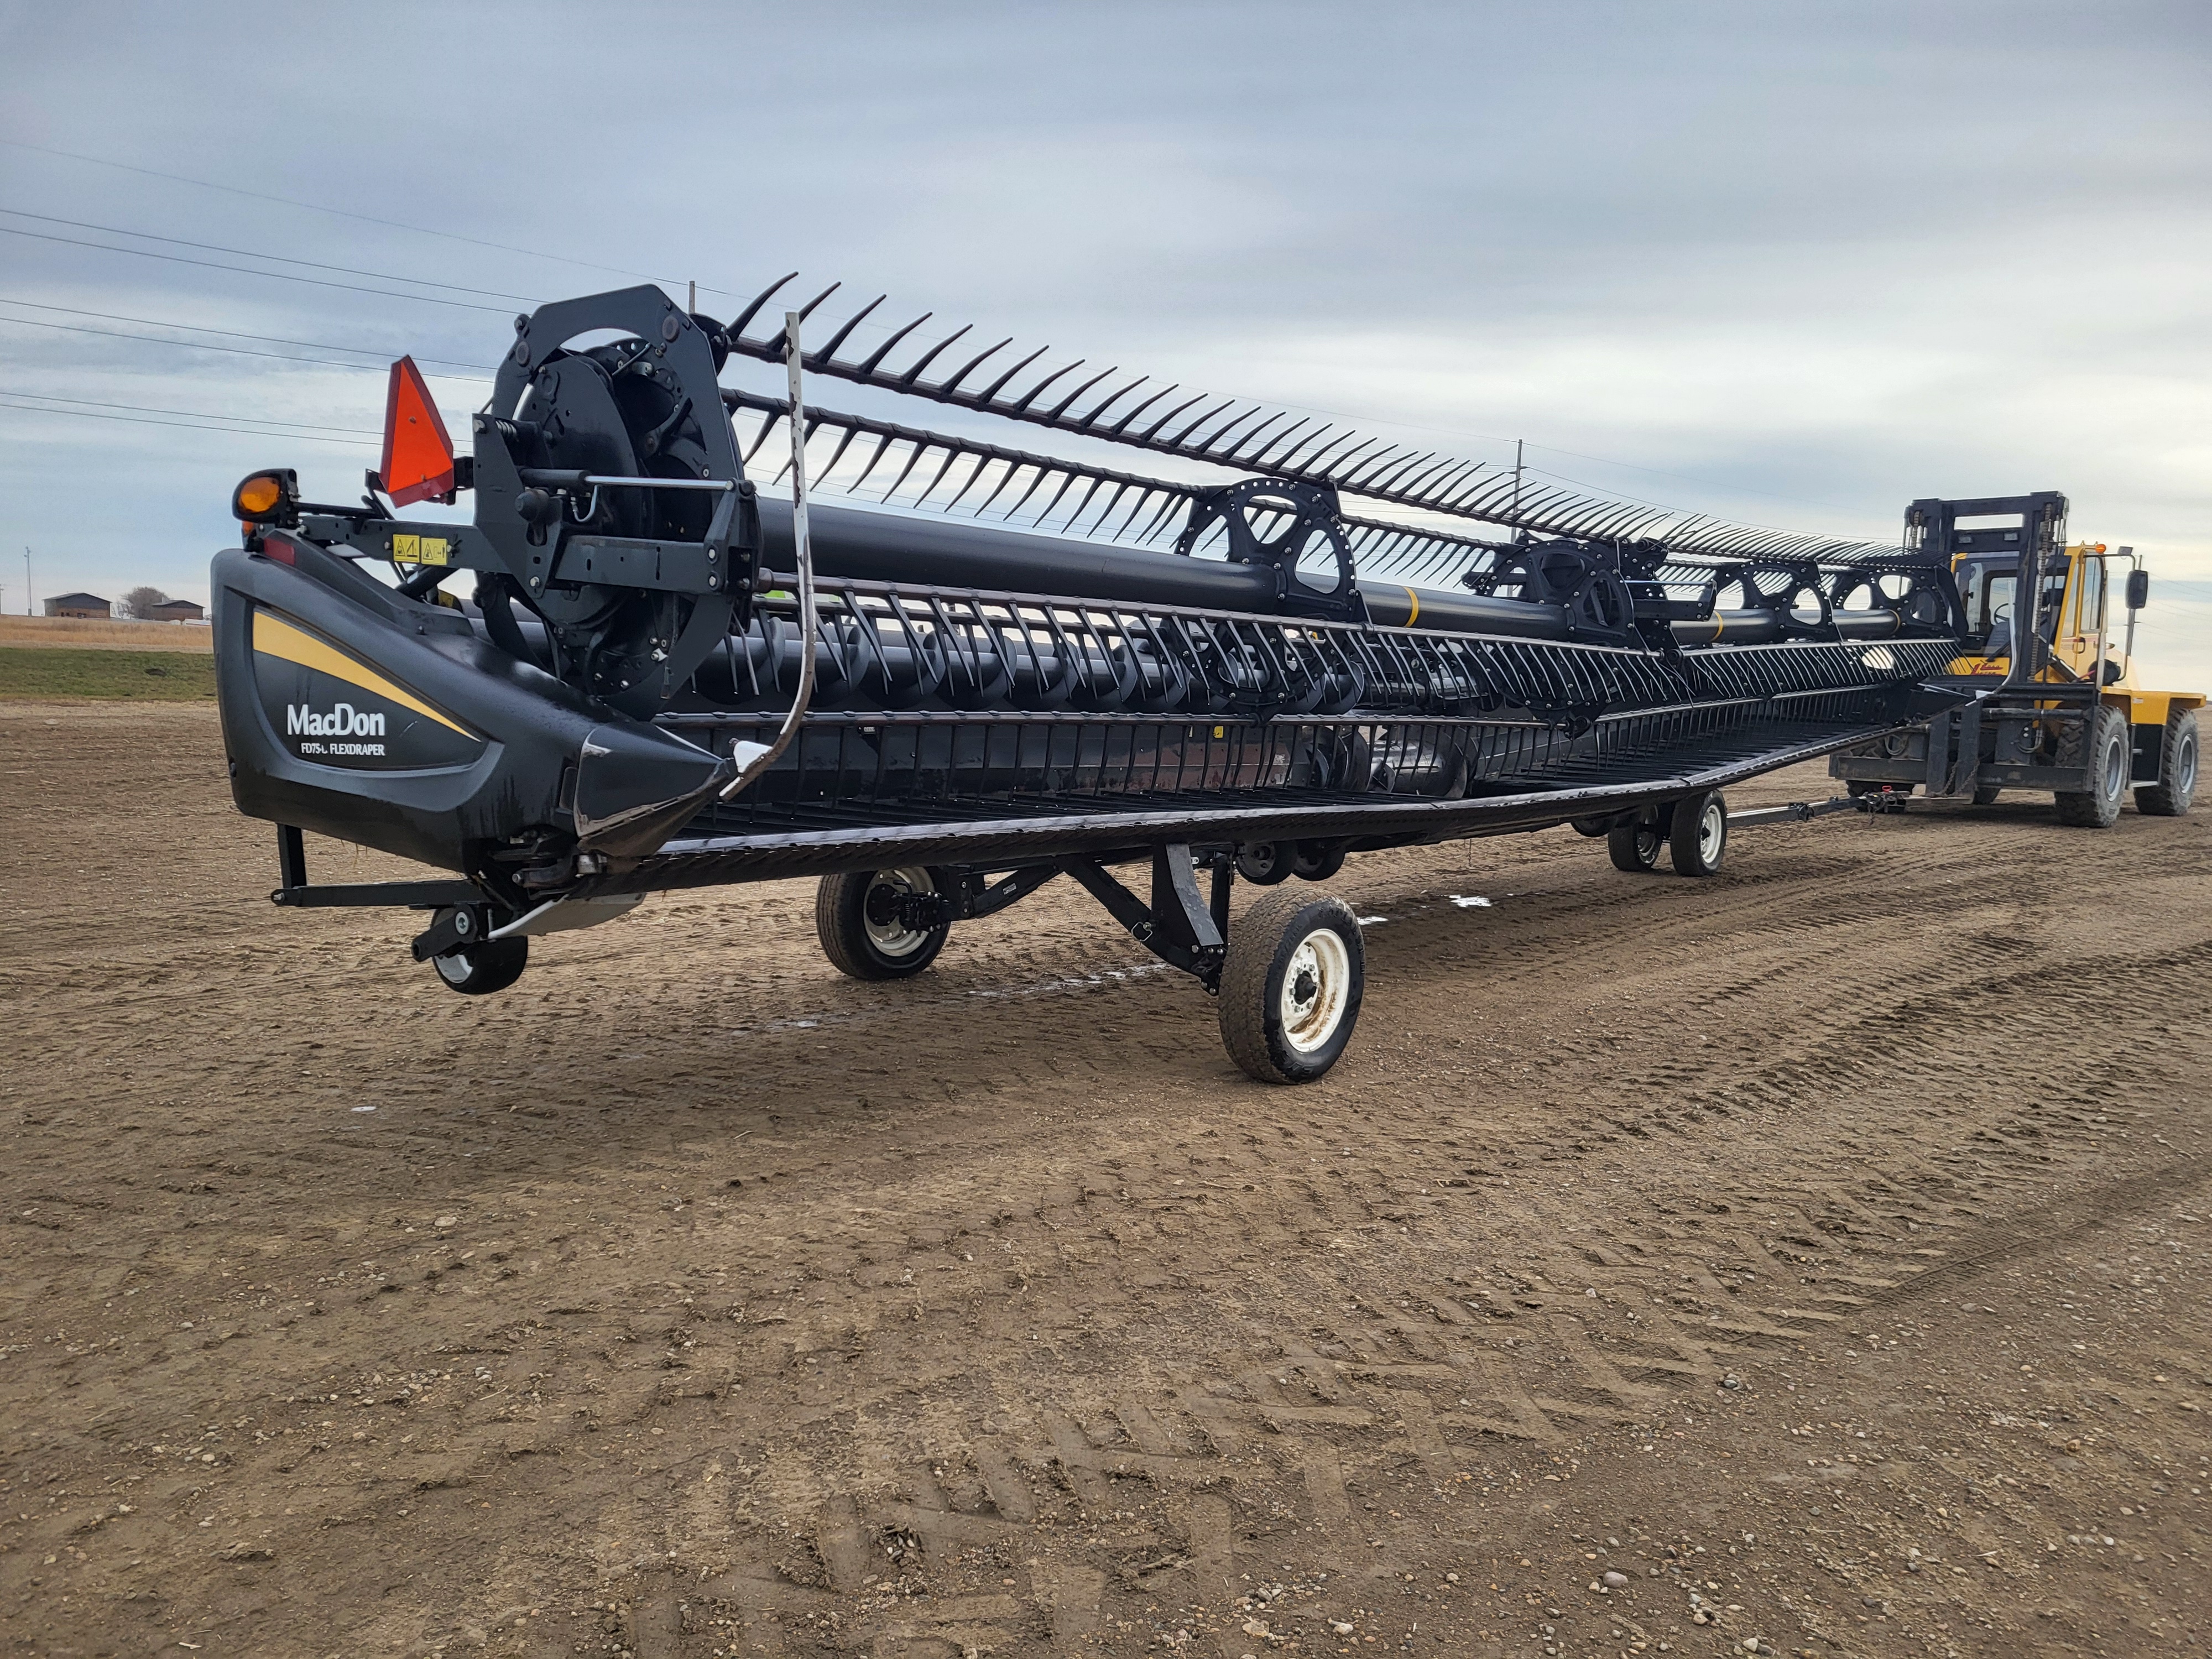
0, 703, 2212, 1659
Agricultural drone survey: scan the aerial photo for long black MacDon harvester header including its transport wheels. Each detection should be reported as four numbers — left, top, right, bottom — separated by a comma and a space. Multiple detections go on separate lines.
212, 285, 1964, 1082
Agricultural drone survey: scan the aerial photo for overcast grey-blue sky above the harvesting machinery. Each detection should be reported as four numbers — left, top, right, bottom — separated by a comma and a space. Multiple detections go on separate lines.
0, 0, 2212, 668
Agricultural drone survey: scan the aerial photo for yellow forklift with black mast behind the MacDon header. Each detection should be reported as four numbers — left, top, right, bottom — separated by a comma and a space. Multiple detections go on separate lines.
1829, 491, 2205, 830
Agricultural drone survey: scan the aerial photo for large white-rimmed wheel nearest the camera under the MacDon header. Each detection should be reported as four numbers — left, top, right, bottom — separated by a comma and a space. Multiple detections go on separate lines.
1217, 891, 1367, 1084
